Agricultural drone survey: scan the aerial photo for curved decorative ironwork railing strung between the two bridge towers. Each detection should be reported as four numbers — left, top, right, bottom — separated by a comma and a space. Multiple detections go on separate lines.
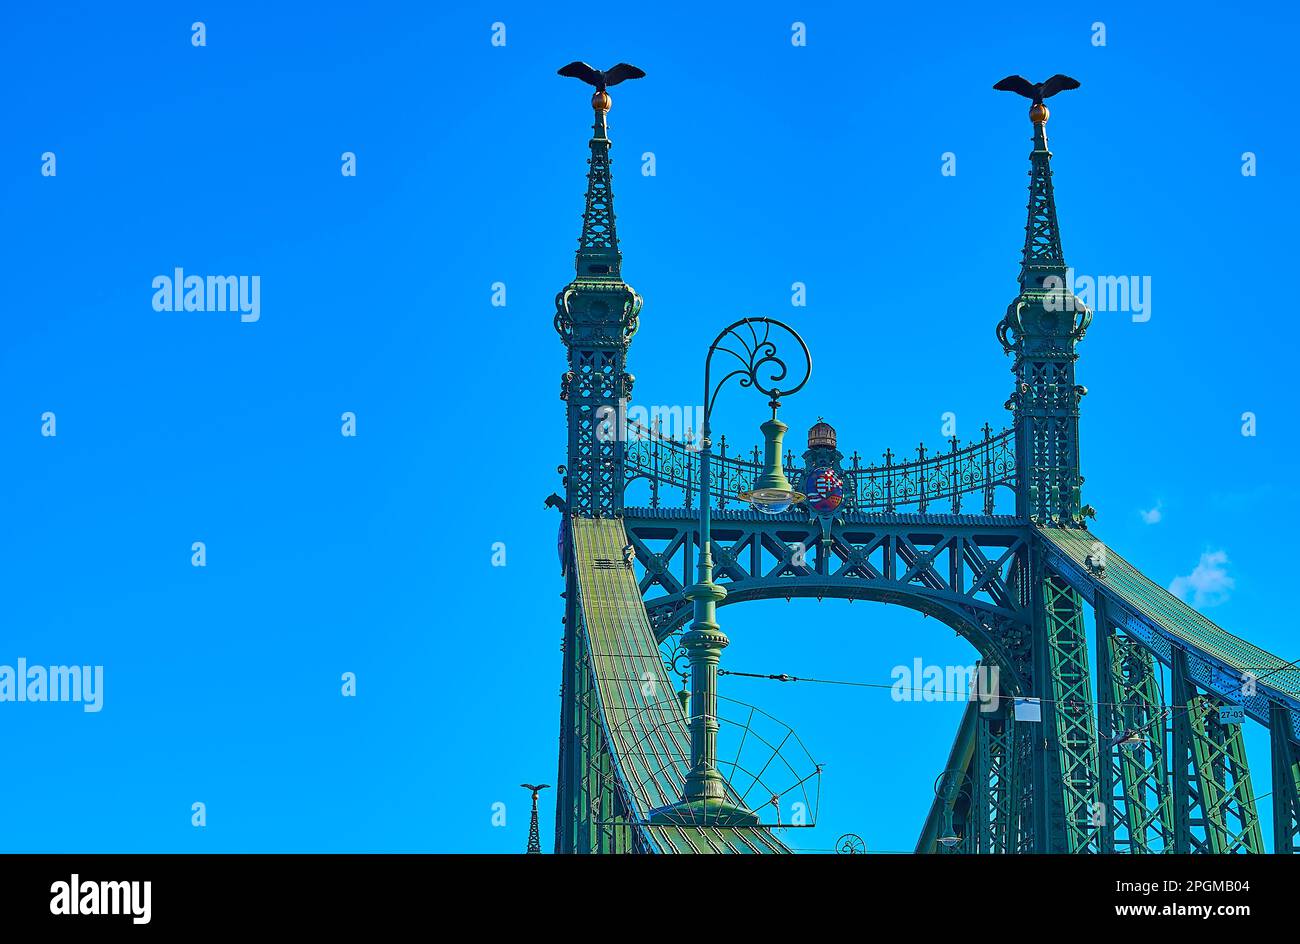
624, 420, 1017, 515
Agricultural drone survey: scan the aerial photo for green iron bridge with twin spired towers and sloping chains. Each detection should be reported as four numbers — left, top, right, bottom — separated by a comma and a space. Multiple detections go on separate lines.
549, 66, 1300, 853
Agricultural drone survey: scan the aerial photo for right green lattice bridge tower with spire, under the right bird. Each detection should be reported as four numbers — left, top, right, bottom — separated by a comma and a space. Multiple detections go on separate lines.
997, 101, 1105, 852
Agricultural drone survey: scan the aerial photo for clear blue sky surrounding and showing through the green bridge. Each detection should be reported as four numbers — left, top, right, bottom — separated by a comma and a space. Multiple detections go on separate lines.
0, 3, 1300, 852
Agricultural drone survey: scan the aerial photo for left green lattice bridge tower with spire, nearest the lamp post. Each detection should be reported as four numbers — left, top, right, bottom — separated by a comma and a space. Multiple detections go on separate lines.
555, 90, 641, 853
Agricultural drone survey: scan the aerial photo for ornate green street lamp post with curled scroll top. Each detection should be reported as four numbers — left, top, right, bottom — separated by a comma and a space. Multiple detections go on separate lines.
650, 319, 813, 826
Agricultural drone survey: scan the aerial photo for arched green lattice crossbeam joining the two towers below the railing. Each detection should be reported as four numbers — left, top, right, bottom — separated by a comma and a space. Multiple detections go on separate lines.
624, 508, 1031, 690
